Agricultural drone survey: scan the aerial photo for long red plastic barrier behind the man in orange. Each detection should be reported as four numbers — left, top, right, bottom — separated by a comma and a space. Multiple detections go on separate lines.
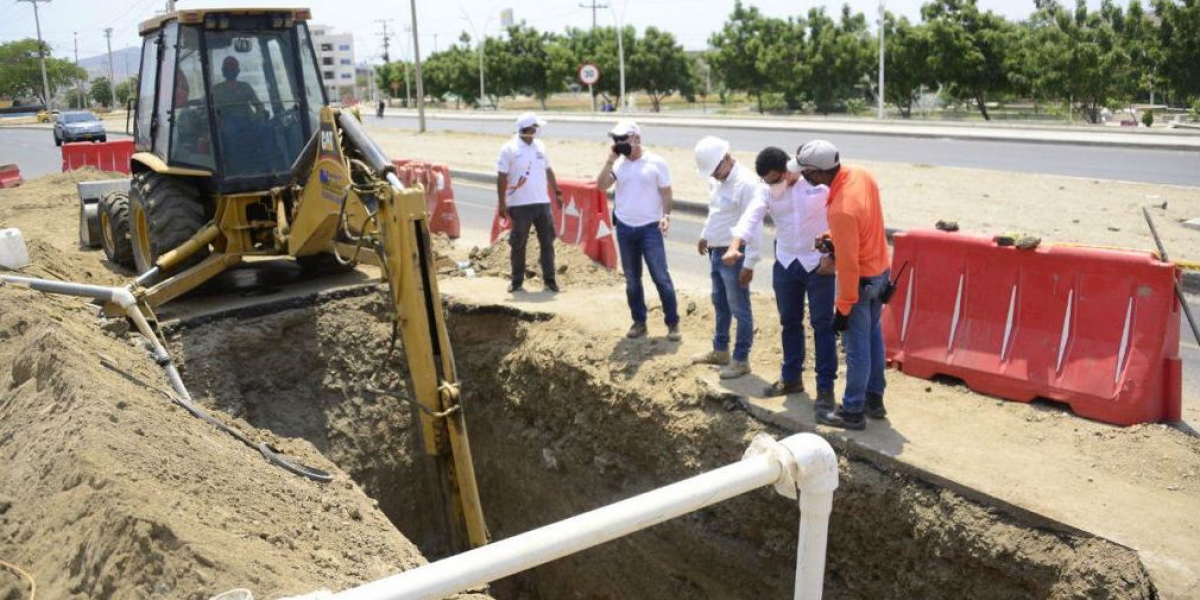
883, 230, 1182, 425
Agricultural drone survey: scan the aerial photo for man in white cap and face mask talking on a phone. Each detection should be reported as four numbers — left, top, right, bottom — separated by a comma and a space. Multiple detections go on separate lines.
596, 120, 683, 342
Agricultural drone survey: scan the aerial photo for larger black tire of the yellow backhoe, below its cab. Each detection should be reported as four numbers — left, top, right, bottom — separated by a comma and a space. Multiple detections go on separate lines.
130, 173, 209, 275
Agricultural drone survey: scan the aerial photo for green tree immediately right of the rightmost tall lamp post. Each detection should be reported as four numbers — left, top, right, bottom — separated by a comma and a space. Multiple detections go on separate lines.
883, 13, 934, 119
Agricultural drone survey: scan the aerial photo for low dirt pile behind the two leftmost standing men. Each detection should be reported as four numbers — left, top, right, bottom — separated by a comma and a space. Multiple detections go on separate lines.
457, 234, 625, 288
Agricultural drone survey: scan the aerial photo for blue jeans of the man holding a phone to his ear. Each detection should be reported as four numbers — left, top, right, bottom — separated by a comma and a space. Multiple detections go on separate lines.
613, 217, 679, 326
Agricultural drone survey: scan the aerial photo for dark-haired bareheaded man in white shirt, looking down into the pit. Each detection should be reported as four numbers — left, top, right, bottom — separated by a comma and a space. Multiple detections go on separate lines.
725, 148, 838, 409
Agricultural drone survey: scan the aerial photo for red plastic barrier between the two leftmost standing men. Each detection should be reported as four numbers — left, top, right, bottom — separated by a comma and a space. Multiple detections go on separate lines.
492, 179, 618, 270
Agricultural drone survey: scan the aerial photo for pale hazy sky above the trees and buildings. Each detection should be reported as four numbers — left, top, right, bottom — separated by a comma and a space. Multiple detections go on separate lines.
0, 0, 1123, 64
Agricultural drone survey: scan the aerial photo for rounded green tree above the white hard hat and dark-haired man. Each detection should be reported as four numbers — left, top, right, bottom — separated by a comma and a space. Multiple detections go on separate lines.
708, 0, 791, 113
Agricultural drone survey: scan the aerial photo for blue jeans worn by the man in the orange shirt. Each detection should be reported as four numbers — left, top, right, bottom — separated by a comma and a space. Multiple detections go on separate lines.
841, 271, 890, 413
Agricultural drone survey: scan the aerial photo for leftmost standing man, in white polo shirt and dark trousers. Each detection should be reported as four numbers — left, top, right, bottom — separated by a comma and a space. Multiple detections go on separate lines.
496, 113, 563, 293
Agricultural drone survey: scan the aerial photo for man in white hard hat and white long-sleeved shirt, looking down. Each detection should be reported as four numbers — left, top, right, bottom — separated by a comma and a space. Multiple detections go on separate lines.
691, 136, 758, 379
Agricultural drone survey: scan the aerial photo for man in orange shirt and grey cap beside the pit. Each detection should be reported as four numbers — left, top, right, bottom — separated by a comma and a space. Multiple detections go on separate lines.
788, 139, 892, 430
